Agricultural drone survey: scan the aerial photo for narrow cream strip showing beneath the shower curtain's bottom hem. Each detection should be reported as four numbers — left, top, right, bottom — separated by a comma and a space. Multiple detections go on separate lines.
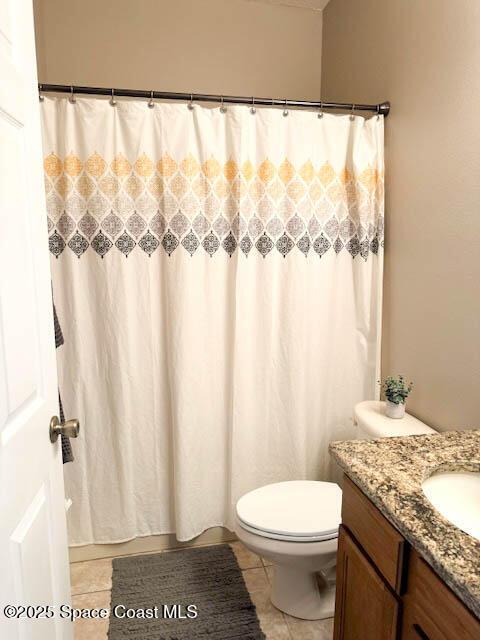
69, 527, 237, 562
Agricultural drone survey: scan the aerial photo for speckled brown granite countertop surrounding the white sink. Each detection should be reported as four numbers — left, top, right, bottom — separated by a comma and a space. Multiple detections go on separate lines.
330, 430, 480, 618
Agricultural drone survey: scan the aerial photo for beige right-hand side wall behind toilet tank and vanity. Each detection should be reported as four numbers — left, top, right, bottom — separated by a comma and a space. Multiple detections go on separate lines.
322, 0, 480, 429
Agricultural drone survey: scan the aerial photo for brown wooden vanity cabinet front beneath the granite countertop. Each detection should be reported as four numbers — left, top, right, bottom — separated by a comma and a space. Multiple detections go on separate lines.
334, 476, 480, 640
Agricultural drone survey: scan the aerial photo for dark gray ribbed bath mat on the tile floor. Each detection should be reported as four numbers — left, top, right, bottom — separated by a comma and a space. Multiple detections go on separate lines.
108, 545, 265, 640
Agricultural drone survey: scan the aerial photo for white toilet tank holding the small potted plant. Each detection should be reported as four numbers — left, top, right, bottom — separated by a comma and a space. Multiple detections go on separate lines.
354, 400, 437, 440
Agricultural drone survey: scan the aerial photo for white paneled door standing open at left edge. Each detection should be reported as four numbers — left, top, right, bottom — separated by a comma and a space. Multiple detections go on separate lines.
0, 0, 73, 640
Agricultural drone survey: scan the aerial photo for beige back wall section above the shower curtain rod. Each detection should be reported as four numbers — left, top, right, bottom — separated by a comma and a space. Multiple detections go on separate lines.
34, 0, 322, 99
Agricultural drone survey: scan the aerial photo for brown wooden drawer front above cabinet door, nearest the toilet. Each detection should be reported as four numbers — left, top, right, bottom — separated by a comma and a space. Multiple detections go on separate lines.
342, 476, 406, 593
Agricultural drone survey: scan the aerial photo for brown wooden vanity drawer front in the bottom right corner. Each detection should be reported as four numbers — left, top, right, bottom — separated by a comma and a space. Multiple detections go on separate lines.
402, 551, 480, 640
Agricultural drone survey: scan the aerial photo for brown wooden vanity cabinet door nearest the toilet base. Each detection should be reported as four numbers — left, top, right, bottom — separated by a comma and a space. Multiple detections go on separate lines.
334, 526, 399, 640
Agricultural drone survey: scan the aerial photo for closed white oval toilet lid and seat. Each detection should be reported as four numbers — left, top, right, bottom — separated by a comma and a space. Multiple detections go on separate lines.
237, 480, 342, 539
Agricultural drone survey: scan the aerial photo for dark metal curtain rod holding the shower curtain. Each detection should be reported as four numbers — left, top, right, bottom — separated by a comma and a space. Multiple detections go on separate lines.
38, 84, 390, 116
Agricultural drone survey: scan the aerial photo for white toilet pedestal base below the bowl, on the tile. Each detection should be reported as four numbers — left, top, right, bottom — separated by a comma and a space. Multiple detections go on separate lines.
271, 564, 335, 620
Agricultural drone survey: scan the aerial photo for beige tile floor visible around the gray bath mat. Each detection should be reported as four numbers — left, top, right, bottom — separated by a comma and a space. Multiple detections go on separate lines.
70, 542, 333, 640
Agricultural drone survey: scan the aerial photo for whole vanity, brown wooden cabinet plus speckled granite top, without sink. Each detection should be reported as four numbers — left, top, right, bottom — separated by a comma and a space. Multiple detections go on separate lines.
330, 431, 480, 640
